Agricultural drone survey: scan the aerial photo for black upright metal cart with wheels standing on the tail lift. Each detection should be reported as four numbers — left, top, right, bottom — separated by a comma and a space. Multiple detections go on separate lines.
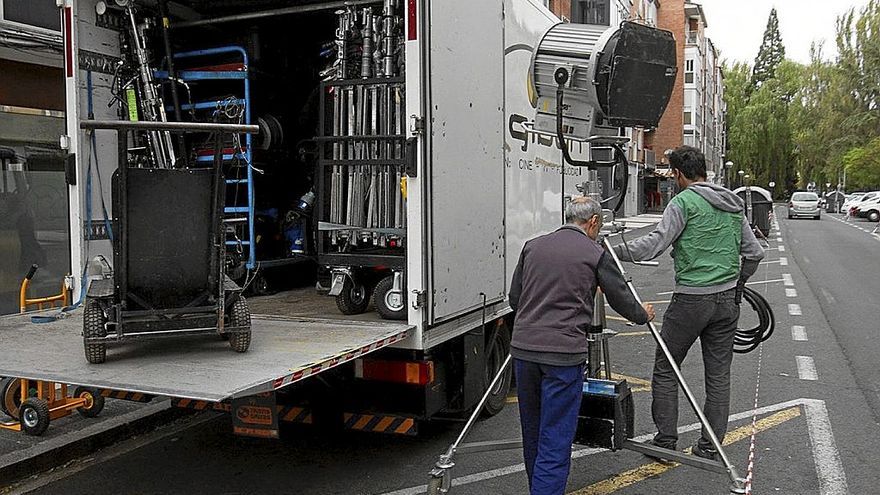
81, 121, 258, 363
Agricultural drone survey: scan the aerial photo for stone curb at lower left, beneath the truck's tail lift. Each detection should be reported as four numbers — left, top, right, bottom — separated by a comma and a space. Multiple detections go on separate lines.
0, 399, 191, 491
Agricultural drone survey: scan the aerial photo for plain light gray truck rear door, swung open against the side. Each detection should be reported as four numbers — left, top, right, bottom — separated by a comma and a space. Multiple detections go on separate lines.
424, 0, 505, 324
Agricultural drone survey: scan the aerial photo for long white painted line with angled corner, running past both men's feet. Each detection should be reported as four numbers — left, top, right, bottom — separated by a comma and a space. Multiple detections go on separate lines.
382, 399, 849, 495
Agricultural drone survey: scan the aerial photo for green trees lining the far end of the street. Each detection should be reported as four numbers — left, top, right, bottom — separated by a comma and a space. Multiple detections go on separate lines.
724, 0, 880, 198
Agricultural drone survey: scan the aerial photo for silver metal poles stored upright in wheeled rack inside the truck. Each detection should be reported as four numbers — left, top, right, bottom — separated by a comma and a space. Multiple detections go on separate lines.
324, 0, 406, 247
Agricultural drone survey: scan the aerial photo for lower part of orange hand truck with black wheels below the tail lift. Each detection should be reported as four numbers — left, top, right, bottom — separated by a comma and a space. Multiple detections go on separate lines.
0, 378, 104, 436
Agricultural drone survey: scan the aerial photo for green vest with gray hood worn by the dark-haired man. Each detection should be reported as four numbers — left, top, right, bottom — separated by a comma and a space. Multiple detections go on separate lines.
672, 189, 742, 287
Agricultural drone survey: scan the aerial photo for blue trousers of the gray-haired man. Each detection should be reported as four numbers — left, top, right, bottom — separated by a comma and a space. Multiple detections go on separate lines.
514, 359, 584, 495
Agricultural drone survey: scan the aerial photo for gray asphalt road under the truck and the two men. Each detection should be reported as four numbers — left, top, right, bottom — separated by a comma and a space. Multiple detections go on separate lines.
6, 208, 880, 495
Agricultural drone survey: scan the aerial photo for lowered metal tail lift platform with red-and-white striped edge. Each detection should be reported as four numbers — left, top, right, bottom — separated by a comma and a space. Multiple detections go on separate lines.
0, 311, 412, 402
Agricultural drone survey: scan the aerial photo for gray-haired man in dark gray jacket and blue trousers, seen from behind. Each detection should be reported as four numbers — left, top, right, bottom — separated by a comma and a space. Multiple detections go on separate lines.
510, 197, 654, 495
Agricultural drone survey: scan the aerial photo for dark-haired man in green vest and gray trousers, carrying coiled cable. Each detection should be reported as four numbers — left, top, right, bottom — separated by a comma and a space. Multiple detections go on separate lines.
614, 146, 764, 459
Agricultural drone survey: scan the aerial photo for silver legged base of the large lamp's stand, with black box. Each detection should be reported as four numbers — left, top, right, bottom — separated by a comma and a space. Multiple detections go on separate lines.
428, 232, 746, 495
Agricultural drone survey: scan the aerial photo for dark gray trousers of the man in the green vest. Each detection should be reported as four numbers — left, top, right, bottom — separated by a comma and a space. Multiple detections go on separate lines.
651, 289, 739, 449
